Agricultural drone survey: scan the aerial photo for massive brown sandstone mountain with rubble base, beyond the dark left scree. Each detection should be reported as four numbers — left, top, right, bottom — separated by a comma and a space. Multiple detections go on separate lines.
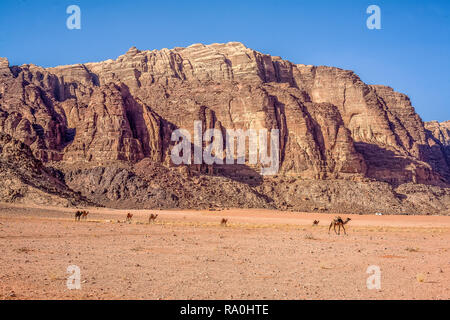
0, 42, 450, 213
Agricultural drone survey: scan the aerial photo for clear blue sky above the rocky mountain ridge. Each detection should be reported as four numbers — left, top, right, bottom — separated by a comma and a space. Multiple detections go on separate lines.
0, 0, 450, 121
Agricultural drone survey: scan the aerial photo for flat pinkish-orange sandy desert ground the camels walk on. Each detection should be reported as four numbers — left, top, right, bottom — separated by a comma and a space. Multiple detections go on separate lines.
0, 204, 450, 299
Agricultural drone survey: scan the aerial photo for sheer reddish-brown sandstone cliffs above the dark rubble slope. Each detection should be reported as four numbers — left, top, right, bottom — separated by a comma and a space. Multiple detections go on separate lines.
0, 42, 450, 212
